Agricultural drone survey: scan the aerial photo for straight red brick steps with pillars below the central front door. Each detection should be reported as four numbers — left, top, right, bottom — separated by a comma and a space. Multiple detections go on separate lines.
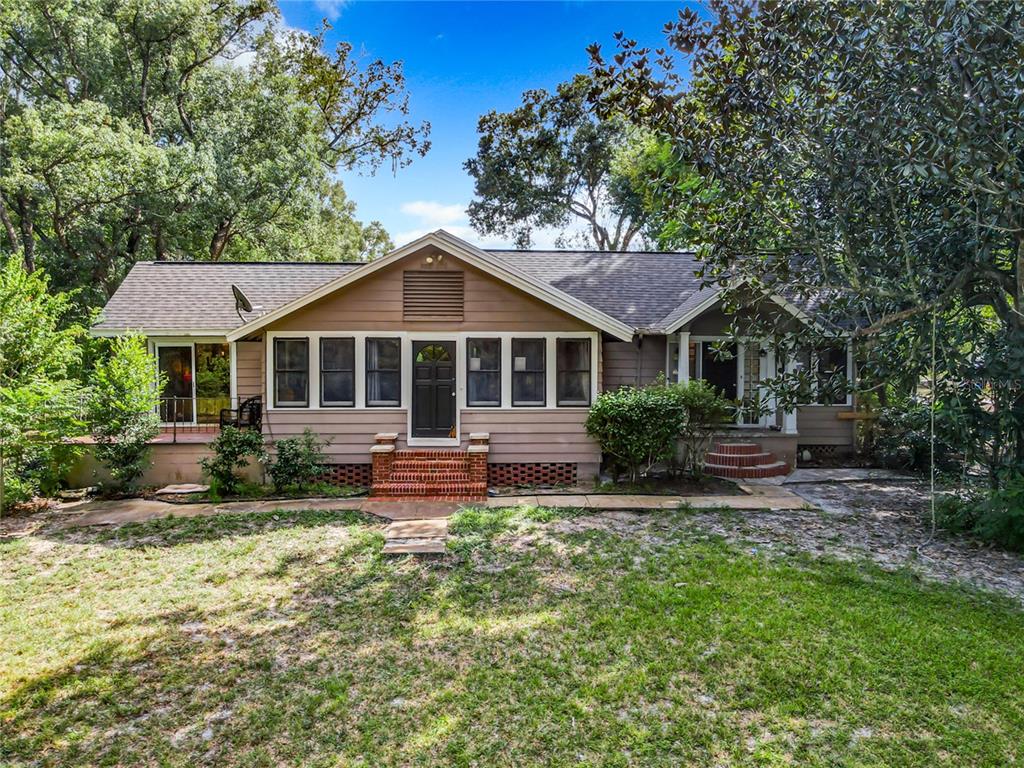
370, 435, 487, 502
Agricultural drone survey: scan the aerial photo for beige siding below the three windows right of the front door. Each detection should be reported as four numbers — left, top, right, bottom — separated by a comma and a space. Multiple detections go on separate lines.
462, 409, 601, 464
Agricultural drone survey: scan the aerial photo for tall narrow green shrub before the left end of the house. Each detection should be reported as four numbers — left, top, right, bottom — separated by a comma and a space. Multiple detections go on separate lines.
88, 336, 162, 487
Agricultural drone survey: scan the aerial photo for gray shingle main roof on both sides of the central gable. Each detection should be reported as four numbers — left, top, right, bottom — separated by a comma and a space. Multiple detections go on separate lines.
94, 250, 700, 332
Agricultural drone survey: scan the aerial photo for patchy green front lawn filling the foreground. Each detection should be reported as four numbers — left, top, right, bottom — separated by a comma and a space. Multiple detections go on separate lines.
0, 510, 1024, 766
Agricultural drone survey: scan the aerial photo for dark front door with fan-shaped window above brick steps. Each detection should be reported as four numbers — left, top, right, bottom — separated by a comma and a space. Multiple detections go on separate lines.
413, 341, 456, 437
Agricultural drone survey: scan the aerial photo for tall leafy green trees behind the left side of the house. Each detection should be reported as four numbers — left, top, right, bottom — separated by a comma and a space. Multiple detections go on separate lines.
0, 0, 429, 318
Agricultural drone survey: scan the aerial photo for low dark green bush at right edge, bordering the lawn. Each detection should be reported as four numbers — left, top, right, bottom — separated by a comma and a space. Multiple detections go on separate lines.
936, 474, 1024, 552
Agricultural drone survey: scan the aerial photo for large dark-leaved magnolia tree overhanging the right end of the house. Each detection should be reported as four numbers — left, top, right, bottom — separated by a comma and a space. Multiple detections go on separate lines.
591, 0, 1024, 485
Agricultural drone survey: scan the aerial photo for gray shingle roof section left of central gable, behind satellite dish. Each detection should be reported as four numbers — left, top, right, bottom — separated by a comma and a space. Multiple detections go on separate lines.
93, 261, 358, 332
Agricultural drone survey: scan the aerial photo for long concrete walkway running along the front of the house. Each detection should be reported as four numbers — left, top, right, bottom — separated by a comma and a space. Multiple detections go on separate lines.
66, 483, 809, 526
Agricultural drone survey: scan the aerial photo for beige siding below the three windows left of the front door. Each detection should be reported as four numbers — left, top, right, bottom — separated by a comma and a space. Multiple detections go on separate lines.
263, 409, 407, 464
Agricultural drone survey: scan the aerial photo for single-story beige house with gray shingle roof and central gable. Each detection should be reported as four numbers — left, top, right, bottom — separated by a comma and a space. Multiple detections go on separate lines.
79, 230, 854, 495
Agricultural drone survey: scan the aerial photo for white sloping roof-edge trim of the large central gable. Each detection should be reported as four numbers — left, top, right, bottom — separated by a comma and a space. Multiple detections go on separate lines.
227, 229, 635, 341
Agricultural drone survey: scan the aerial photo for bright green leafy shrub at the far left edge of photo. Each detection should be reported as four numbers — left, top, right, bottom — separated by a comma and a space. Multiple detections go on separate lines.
0, 258, 84, 506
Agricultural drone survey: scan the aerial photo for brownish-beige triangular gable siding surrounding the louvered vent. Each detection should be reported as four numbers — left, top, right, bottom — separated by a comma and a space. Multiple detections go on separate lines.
268, 251, 589, 331
